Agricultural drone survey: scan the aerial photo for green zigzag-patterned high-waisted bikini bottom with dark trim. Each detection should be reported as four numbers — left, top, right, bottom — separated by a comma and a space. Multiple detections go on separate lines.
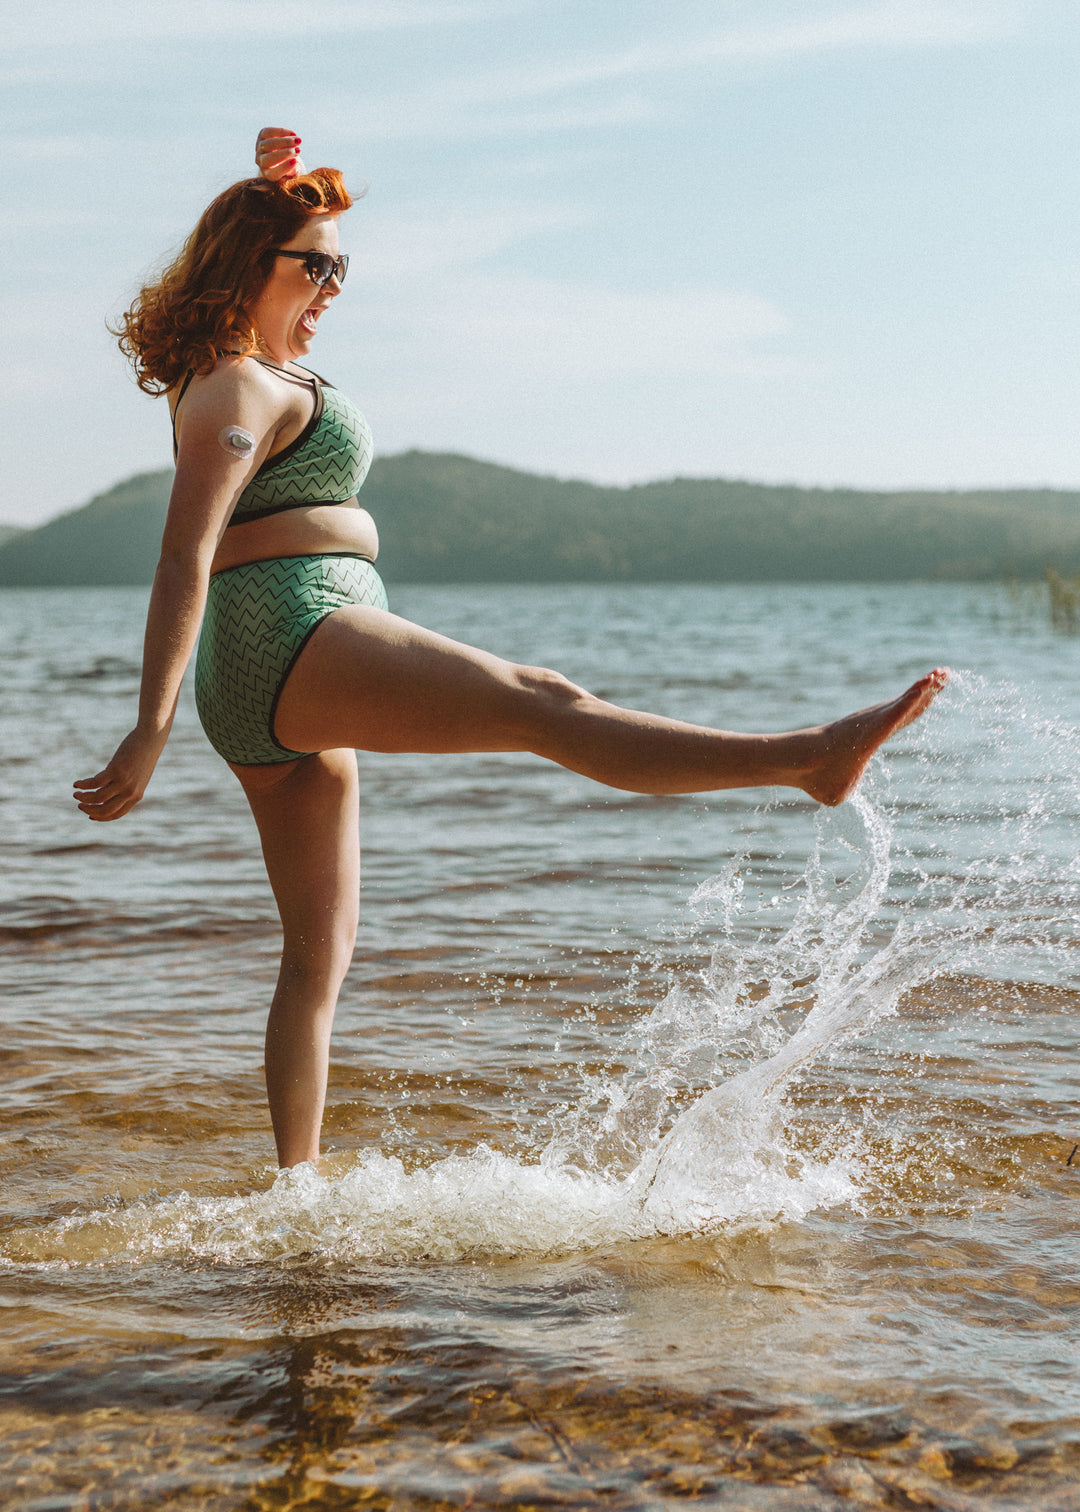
195, 553, 387, 767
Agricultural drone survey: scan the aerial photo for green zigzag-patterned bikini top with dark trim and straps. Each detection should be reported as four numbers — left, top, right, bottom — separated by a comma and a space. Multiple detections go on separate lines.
172, 357, 372, 525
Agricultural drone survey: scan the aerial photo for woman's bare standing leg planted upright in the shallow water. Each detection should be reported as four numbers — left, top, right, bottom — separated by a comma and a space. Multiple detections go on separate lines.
233, 750, 360, 1166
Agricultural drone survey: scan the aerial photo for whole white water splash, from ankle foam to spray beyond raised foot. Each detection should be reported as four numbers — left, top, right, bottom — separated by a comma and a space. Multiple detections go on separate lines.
10, 674, 1080, 1266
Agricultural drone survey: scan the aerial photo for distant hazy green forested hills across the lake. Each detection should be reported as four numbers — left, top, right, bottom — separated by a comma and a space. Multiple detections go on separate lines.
0, 451, 1080, 587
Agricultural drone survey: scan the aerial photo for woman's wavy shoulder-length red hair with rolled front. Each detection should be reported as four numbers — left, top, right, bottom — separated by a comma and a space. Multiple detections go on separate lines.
112, 168, 352, 395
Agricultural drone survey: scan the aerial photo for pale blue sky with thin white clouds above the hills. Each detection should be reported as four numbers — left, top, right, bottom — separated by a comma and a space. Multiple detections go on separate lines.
0, 0, 1080, 525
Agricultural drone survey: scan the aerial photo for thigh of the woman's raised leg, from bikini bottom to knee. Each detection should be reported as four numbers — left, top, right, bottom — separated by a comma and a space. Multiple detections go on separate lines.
274, 605, 587, 751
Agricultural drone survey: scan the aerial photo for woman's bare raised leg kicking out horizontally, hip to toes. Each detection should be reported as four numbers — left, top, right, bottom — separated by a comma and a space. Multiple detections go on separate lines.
275, 606, 948, 803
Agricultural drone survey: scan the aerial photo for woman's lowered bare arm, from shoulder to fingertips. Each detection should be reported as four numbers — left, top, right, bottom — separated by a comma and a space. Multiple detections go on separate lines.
74, 361, 280, 820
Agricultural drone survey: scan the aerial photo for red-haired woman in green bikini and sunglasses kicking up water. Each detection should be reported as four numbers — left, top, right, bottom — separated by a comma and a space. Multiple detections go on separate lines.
76, 129, 947, 1166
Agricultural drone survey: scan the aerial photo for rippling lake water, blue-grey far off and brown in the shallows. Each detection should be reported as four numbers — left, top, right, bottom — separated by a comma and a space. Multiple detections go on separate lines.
0, 585, 1080, 1512
